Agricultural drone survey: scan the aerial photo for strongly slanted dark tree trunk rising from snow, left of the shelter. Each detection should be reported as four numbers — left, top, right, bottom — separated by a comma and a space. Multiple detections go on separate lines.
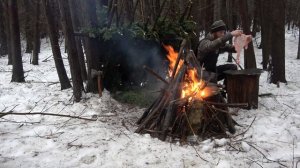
42, 0, 72, 90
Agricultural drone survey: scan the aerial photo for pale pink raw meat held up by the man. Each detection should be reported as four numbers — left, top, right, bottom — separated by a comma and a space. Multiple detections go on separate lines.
233, 34, 252, 64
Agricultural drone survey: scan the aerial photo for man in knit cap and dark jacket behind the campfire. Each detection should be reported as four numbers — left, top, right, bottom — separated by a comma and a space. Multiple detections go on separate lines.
197, 20, 243, 81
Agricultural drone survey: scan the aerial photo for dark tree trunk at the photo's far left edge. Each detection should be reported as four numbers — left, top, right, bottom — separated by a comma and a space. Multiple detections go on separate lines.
0, 3, 8, 56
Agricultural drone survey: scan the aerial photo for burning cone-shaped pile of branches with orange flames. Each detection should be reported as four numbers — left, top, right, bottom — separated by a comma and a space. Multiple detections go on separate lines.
135, 40, 247, 143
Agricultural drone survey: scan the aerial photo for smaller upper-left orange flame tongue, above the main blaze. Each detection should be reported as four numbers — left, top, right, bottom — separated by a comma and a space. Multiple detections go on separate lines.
164, 45, 183, 77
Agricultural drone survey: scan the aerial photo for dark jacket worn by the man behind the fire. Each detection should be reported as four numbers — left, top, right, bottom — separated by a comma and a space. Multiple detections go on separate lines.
197, 33, 235, 72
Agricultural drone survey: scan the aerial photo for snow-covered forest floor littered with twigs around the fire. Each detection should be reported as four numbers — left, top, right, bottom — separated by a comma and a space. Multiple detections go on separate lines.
0, 32, 300, 168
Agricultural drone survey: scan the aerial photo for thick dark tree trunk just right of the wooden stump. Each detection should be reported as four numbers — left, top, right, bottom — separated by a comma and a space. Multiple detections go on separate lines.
270, 0, 286, 84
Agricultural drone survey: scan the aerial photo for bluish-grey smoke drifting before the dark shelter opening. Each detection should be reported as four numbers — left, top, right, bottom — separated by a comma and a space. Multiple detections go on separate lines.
116, 37, 167, 86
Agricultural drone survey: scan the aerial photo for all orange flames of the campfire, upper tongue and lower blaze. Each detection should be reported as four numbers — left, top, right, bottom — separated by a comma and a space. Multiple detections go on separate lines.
164, 45, 215, 101
